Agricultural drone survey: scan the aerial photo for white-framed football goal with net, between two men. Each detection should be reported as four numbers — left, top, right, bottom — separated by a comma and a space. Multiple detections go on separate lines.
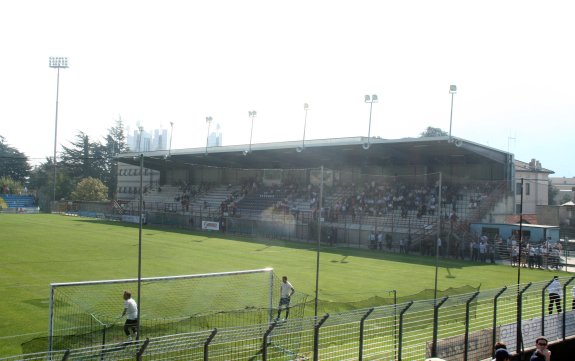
48, 268, 280, 351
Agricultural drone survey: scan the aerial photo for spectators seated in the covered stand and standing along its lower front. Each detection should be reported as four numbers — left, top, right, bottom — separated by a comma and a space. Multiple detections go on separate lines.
148, 178, 561, 268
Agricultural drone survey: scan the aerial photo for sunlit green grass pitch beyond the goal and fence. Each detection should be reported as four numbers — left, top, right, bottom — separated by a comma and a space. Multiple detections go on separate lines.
0, 214, 557, 357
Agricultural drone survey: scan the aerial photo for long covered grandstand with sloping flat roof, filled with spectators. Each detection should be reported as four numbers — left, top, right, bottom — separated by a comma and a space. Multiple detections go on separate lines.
111, 136, 557, 258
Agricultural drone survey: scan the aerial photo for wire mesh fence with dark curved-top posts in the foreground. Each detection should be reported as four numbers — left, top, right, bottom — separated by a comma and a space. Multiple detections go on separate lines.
4, 277, 575, 361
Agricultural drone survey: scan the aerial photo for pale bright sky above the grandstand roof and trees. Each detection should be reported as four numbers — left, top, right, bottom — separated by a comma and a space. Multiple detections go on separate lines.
0, 0, 575, 177
